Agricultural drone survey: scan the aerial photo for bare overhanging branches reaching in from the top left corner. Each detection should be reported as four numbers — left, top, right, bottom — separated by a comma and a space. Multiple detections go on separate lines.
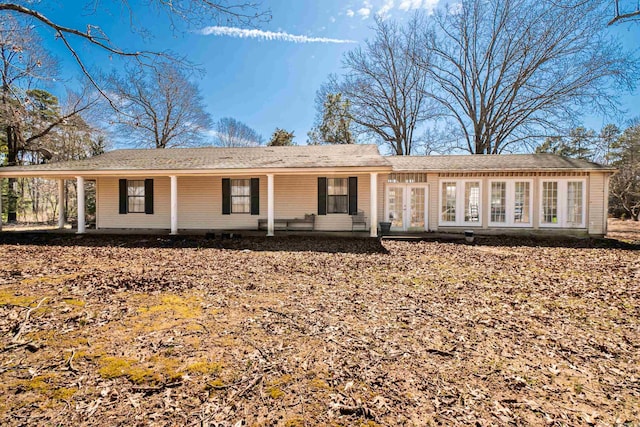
0, 0, 271, 107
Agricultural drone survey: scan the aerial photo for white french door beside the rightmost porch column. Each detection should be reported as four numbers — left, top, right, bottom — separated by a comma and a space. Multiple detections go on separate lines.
385, 184, 429, 232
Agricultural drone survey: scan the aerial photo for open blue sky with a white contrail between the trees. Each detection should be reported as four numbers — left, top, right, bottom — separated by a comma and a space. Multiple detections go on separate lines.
27, 0, 640, 143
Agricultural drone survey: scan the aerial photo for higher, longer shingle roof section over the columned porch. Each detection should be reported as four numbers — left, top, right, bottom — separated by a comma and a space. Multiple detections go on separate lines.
0, 145, 389, 173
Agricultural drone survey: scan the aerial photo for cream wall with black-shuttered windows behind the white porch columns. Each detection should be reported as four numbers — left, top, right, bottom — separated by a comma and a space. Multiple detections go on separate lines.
96, 174, 371, 231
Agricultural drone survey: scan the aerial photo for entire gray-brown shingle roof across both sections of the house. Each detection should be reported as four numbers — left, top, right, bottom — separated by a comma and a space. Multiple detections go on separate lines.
0, 144, 613, 176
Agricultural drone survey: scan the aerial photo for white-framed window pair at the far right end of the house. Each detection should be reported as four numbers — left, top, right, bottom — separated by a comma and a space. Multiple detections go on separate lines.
540, 179, 586, 228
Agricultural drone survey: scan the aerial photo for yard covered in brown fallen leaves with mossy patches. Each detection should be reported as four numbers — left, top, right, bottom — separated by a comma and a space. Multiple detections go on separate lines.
0, 236, 640, 426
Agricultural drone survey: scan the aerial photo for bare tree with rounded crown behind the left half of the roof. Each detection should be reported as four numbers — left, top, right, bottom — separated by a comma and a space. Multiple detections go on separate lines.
105, 62, 211, 148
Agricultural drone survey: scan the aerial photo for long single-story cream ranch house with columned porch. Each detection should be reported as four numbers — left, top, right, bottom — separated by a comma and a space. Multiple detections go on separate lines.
0, 145, 614, 237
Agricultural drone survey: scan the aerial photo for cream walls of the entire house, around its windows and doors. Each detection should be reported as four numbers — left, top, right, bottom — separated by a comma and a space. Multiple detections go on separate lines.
97, 172, 608, 235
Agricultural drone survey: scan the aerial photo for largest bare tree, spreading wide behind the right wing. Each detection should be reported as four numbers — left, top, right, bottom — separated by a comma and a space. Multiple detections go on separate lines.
418, 0, 638, 154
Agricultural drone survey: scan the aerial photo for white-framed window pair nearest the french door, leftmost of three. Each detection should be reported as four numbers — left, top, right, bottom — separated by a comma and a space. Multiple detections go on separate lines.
440, 180, 482, 226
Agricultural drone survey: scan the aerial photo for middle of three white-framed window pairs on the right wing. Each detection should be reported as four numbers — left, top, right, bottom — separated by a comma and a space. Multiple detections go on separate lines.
489, 180, 532, 227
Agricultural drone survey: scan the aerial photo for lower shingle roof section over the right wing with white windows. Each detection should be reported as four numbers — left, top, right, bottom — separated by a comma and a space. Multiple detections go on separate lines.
387, 154, 611, 172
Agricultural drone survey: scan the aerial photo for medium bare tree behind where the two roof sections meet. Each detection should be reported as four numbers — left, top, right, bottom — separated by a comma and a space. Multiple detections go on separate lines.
330, 18, 433, 155
